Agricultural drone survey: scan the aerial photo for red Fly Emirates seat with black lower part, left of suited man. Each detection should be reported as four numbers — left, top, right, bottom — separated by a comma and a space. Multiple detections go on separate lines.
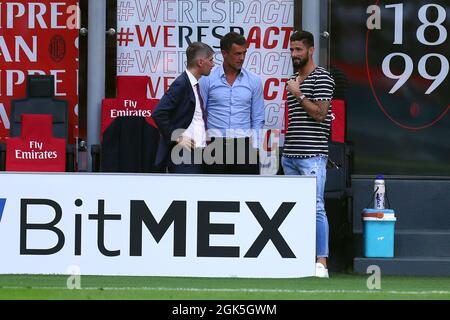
92, 76, 160, 172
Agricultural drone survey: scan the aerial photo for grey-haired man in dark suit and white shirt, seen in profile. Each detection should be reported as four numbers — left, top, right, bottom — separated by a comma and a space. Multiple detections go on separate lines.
152, 42, 214, 173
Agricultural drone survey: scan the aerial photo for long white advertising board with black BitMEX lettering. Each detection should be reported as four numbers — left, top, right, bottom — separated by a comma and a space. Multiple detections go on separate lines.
0, 173, 316, 278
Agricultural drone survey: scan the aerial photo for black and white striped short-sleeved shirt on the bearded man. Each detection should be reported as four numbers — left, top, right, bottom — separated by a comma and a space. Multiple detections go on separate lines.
283, 67, 334, 158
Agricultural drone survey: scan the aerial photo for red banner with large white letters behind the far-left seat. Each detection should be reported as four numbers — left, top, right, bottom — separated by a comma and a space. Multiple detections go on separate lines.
0, 0, 78, 143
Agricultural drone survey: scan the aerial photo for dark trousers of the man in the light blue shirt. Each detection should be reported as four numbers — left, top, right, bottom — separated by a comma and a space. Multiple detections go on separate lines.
204, 137, 259, 174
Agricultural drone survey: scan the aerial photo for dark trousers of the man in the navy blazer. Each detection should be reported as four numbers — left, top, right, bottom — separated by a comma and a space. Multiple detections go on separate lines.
167, 148, 205, 174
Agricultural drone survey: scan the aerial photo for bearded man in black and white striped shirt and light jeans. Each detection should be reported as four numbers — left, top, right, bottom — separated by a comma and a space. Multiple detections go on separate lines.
281, 31, 334, 278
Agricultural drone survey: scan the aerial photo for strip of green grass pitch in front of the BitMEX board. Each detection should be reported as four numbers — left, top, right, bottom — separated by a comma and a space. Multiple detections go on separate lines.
0, 274, 450, 300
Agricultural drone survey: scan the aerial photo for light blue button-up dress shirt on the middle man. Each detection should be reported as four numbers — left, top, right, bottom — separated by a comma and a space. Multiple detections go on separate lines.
199, 66, 265, 147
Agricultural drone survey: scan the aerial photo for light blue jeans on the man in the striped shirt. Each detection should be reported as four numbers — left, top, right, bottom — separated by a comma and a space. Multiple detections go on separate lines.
281, 155, 329, 257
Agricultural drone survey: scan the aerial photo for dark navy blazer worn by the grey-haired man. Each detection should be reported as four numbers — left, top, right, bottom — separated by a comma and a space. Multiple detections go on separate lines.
152, 71, 195, 160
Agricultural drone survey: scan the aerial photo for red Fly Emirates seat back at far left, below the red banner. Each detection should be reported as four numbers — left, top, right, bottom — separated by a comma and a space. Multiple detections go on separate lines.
6, 114, 66, 172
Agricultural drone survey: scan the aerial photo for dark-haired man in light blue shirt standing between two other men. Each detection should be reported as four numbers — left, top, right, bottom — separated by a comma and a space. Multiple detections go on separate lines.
200, 32, 265, 174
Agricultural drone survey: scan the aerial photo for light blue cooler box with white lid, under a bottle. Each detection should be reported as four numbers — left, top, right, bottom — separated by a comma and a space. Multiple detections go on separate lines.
362, 209, 397, 258
